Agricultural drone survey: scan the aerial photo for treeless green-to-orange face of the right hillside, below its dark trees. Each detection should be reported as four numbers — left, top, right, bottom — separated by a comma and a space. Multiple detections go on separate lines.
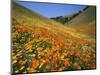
66, 6, 96, 38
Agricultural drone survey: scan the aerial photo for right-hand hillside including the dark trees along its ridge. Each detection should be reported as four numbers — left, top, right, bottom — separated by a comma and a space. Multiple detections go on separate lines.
51, 6, 96, 39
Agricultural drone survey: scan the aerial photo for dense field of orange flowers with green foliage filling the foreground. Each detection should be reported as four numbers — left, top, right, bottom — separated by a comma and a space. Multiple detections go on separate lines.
12, 26, 96, 73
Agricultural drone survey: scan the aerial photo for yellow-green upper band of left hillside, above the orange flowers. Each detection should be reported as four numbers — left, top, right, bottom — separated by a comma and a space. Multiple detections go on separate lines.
12, 3, 93, 38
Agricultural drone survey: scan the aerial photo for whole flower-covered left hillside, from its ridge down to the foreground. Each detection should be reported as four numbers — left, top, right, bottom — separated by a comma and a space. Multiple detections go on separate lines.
12, 3, 96, 73
